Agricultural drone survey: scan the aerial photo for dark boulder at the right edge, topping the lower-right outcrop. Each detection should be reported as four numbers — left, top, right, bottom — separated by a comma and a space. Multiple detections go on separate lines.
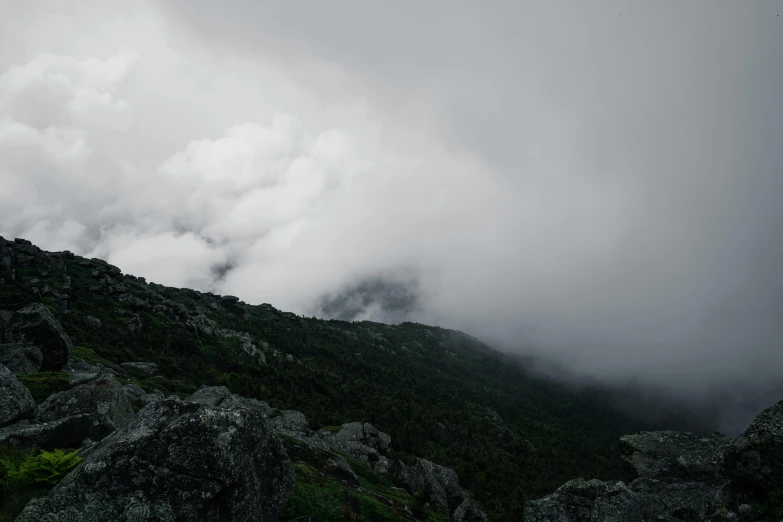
723, 401, 783, 491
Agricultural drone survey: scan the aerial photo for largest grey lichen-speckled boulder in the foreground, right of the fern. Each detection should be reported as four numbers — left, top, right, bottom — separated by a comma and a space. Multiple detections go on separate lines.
17, 398, 294, 522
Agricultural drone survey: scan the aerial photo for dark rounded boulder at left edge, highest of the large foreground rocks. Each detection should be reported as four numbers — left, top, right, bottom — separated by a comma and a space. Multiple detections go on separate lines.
3, 303, 73, 371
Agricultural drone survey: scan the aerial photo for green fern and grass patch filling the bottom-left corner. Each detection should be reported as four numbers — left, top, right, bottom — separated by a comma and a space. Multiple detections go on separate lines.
0, 446, 82, 522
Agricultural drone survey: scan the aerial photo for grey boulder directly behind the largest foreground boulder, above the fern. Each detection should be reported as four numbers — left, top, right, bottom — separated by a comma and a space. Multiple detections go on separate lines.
36, 375, 133, 440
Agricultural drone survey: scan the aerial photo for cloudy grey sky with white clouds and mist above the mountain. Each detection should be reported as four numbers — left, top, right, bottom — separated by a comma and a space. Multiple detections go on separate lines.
0, 0, 783, 432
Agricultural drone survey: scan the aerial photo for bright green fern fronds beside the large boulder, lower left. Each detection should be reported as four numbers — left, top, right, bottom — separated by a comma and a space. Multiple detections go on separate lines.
0, 449, 84, 489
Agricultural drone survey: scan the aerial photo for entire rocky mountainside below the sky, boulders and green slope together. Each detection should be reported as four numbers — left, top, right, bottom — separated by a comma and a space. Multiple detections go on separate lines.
0, 238, 783, 522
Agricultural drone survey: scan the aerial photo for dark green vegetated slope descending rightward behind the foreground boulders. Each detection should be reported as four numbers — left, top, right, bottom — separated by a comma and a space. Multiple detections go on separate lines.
0, 238, 647, 521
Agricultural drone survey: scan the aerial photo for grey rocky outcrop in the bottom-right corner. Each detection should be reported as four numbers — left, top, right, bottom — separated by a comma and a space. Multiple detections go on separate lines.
525, 401, 783, 522
